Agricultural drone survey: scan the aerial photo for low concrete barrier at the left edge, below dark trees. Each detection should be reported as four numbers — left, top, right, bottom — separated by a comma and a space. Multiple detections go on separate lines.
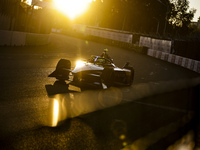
0, 30, 50, 46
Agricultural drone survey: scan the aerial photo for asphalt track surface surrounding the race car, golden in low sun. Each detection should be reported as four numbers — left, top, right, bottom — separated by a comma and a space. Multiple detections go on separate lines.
0, 34, 199, 149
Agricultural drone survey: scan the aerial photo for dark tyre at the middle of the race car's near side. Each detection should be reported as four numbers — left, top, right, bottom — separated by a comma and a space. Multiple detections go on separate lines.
101, 67, 114, 87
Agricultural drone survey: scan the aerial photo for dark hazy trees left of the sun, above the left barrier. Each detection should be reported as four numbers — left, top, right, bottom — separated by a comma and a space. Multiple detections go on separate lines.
0, 0, 53, 33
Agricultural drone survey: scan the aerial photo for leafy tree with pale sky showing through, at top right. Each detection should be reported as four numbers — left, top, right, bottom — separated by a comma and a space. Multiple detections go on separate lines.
168, 0, 196, 35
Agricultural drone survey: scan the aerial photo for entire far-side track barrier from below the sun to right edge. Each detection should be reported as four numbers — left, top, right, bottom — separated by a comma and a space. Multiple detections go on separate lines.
63, 25, 200, 73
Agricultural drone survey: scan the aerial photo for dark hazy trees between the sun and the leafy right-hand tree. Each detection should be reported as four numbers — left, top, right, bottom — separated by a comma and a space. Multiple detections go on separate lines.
87, 0, 168, 32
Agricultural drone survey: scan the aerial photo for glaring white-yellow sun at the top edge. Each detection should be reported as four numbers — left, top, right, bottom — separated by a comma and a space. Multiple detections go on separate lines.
53, 0, 93, 19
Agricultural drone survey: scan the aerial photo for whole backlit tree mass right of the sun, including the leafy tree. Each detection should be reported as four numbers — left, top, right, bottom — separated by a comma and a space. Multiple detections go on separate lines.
83, 0, 195, 34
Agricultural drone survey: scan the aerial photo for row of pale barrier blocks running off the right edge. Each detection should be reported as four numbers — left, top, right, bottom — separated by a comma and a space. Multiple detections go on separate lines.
147, 49, 200, 73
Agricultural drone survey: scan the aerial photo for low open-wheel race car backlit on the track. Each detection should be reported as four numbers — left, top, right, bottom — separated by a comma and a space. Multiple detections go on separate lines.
48, 56, 134, 89
